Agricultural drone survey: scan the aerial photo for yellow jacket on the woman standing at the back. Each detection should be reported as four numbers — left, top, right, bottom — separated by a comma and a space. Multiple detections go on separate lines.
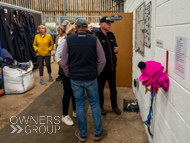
33, 33, 54, 56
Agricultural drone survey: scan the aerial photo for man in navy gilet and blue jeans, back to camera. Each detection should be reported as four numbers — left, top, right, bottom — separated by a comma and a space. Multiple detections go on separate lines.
61, 18, 107, 141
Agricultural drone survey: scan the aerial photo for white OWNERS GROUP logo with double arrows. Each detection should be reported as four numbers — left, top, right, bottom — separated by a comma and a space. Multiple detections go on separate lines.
10, 116, 61, 134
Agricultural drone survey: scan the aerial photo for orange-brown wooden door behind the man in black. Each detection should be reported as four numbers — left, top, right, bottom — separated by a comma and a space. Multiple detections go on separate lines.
101, 13, 133, 87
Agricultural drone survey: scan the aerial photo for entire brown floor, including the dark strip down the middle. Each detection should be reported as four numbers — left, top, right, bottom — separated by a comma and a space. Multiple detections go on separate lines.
0, 63, 148, 143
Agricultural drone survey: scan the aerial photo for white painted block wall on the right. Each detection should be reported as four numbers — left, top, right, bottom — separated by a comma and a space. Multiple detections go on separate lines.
124, 0, 190, 143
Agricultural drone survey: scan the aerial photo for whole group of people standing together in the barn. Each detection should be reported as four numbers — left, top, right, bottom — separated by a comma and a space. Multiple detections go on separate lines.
33, 16, 121, 141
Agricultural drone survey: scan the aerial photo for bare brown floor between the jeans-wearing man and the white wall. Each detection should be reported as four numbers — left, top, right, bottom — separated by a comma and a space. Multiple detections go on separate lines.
84, 87, 148, 143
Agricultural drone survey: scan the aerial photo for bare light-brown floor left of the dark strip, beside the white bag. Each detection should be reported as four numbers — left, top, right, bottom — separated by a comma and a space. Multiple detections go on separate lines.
0, 62, 58, 130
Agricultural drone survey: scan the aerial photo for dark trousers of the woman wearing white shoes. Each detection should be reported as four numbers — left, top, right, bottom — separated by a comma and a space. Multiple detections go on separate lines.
61, 75, 76, 115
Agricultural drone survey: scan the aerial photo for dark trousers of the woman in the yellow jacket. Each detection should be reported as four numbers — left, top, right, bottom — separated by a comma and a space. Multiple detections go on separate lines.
38, 56, 51, 76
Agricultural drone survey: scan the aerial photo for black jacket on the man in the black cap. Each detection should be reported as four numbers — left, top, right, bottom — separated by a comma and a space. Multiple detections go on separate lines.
95, 29, 117, 70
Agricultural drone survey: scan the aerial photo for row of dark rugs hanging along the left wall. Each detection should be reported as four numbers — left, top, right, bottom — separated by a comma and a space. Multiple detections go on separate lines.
0, 7, 37, 64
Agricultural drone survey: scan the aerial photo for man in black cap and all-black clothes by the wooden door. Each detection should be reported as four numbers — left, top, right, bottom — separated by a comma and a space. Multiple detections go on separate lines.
95, 16, 121, 115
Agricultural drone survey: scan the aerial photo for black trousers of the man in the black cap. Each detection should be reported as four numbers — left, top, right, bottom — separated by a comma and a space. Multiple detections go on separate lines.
98, 70, 117, 108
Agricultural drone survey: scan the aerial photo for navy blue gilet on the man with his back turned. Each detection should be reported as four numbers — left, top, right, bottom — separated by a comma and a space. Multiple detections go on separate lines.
66, 33, 98, 81
